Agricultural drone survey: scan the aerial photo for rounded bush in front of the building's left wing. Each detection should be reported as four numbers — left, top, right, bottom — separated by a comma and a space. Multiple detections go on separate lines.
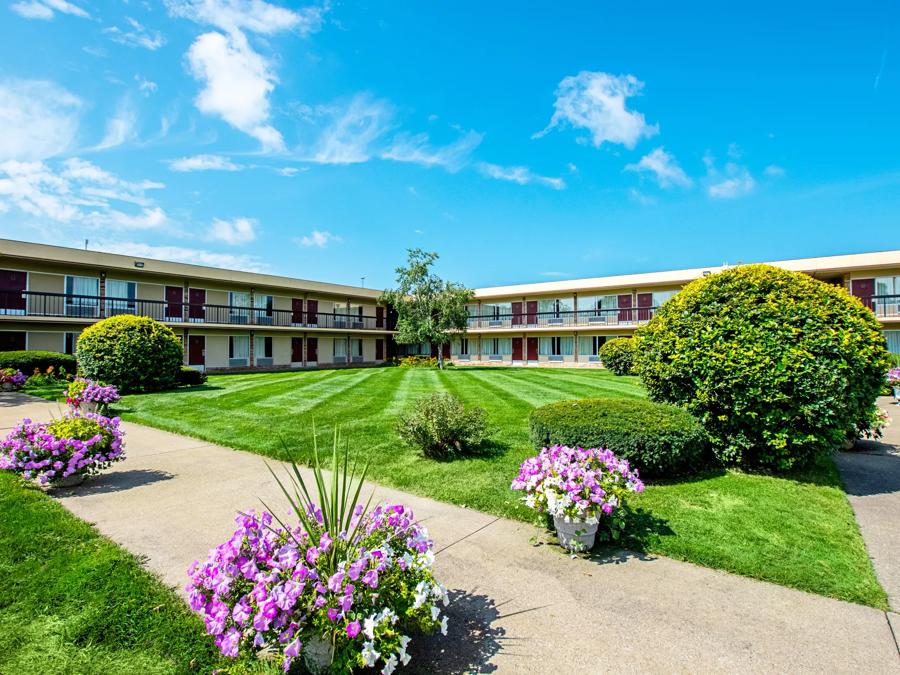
78, 314, 183, 393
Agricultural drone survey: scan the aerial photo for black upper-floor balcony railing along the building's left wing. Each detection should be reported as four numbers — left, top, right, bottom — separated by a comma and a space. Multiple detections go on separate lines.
0, 291, 387, 330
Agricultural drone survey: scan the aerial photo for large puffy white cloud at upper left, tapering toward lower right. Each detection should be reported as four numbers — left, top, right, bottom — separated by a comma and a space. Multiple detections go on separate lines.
188, 32, 284, 151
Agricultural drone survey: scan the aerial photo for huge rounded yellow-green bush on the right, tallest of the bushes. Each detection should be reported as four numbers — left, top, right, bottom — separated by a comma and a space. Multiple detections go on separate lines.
636, 265, 890, 469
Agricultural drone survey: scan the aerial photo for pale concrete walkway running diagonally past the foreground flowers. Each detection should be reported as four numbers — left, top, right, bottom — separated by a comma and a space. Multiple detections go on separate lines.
0, 395, 900, 673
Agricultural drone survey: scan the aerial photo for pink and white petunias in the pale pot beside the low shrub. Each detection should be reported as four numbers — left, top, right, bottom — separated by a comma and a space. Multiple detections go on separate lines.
512, 445, 644, 532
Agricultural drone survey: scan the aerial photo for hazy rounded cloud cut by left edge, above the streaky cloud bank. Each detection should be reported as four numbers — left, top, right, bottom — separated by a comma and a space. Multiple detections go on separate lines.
0, 80, 82, 161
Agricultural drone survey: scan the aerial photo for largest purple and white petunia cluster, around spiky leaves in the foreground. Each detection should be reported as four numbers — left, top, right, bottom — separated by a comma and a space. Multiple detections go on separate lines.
186, 504, 448, 675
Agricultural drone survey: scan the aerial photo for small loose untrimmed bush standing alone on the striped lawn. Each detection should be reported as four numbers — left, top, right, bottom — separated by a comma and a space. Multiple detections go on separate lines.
397, 392, 487, 459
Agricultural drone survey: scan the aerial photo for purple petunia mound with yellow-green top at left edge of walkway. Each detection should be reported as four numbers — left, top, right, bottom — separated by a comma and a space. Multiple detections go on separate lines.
0, 413, 125, 484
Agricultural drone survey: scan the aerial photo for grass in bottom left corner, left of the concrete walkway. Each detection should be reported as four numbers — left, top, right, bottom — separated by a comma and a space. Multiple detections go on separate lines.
0, 471, 277, 673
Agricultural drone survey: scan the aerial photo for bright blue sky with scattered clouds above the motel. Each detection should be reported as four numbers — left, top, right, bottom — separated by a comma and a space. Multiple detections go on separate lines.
0, 0, 900, 287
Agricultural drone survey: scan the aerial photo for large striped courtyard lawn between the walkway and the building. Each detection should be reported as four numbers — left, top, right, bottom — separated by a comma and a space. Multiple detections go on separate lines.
118, 367, 886, 607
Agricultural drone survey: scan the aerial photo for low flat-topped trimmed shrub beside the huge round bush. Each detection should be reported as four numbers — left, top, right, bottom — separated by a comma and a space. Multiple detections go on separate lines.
529, 398, 707, 476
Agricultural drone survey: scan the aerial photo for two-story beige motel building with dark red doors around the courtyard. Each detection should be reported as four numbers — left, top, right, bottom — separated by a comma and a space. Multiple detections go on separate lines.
0, 240, 900, 371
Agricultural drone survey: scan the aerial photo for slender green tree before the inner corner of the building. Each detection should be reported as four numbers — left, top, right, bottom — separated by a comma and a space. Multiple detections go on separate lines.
381, 248, 475, 368
